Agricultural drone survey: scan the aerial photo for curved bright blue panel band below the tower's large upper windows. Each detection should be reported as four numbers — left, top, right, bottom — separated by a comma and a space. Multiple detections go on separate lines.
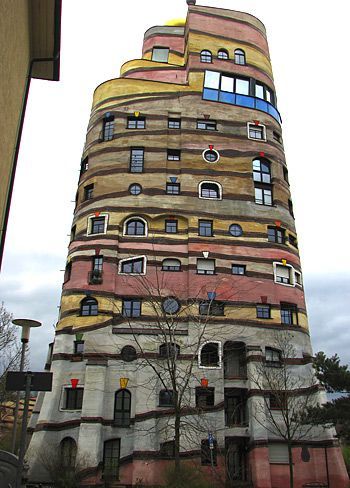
203, 88, 282, 124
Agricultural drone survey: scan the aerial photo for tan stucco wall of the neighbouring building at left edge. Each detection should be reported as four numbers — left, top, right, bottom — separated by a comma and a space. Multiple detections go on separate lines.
0, 0, 30, 255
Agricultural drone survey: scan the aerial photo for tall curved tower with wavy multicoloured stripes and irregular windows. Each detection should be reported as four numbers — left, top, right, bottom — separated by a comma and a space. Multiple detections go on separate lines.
29, 1, 348, 488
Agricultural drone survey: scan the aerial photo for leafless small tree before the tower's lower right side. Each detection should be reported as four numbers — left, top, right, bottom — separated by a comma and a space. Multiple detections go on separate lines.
250, 331, 319, 488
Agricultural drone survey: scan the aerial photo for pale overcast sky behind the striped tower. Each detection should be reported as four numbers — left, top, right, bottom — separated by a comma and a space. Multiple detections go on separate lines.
0, 0, 350, 370
